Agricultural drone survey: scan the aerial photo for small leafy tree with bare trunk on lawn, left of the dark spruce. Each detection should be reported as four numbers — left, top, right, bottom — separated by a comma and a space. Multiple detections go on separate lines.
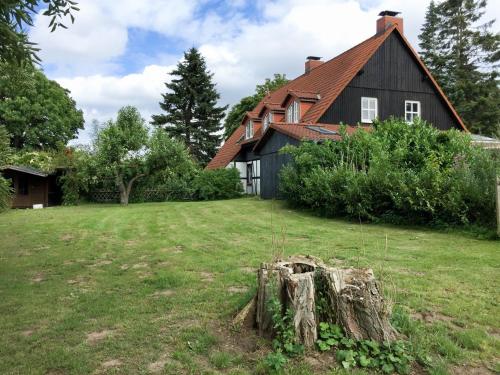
96, 106, 192, 205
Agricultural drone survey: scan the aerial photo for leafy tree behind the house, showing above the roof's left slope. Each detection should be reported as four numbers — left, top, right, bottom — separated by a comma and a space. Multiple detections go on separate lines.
224, 74, 288, 139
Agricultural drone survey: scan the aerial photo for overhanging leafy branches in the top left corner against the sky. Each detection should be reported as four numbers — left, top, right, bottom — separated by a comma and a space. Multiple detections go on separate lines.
0, 0, 79, 64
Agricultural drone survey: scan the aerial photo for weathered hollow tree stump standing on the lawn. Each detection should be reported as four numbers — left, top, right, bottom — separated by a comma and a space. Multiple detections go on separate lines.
234, 256, 396, 348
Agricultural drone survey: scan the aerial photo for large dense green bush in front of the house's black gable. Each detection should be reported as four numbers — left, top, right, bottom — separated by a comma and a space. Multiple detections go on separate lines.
280, 119, 499, 226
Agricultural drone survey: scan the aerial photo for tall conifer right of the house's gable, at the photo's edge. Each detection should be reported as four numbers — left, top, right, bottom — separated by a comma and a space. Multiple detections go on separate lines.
419, 0, 500, 135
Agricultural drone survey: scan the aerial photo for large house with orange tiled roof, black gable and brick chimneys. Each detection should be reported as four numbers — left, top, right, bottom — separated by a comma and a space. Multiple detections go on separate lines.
207, 11, 467, 198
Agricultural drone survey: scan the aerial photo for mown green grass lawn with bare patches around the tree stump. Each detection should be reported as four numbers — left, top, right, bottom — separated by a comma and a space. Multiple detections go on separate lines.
0, 199, 500, 374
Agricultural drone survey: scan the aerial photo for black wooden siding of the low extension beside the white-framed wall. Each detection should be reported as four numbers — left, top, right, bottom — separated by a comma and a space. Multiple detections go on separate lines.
260, 131, 300, 199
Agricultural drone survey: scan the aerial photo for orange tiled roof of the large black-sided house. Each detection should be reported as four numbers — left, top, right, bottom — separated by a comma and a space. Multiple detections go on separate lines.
207, 26, 467, 168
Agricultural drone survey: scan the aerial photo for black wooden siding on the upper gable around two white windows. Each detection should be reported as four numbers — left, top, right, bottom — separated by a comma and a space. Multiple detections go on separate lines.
319, 33, 461, 130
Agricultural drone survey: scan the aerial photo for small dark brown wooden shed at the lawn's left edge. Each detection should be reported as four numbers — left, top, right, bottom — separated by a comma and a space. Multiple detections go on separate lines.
2, 165, 62, 208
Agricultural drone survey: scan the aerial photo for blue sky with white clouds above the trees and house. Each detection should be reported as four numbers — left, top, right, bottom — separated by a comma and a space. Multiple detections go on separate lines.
30, 0, 500, 143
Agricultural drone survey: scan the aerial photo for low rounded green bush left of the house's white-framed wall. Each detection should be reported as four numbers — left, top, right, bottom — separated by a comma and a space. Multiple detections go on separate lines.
193, 168, 243, 201
